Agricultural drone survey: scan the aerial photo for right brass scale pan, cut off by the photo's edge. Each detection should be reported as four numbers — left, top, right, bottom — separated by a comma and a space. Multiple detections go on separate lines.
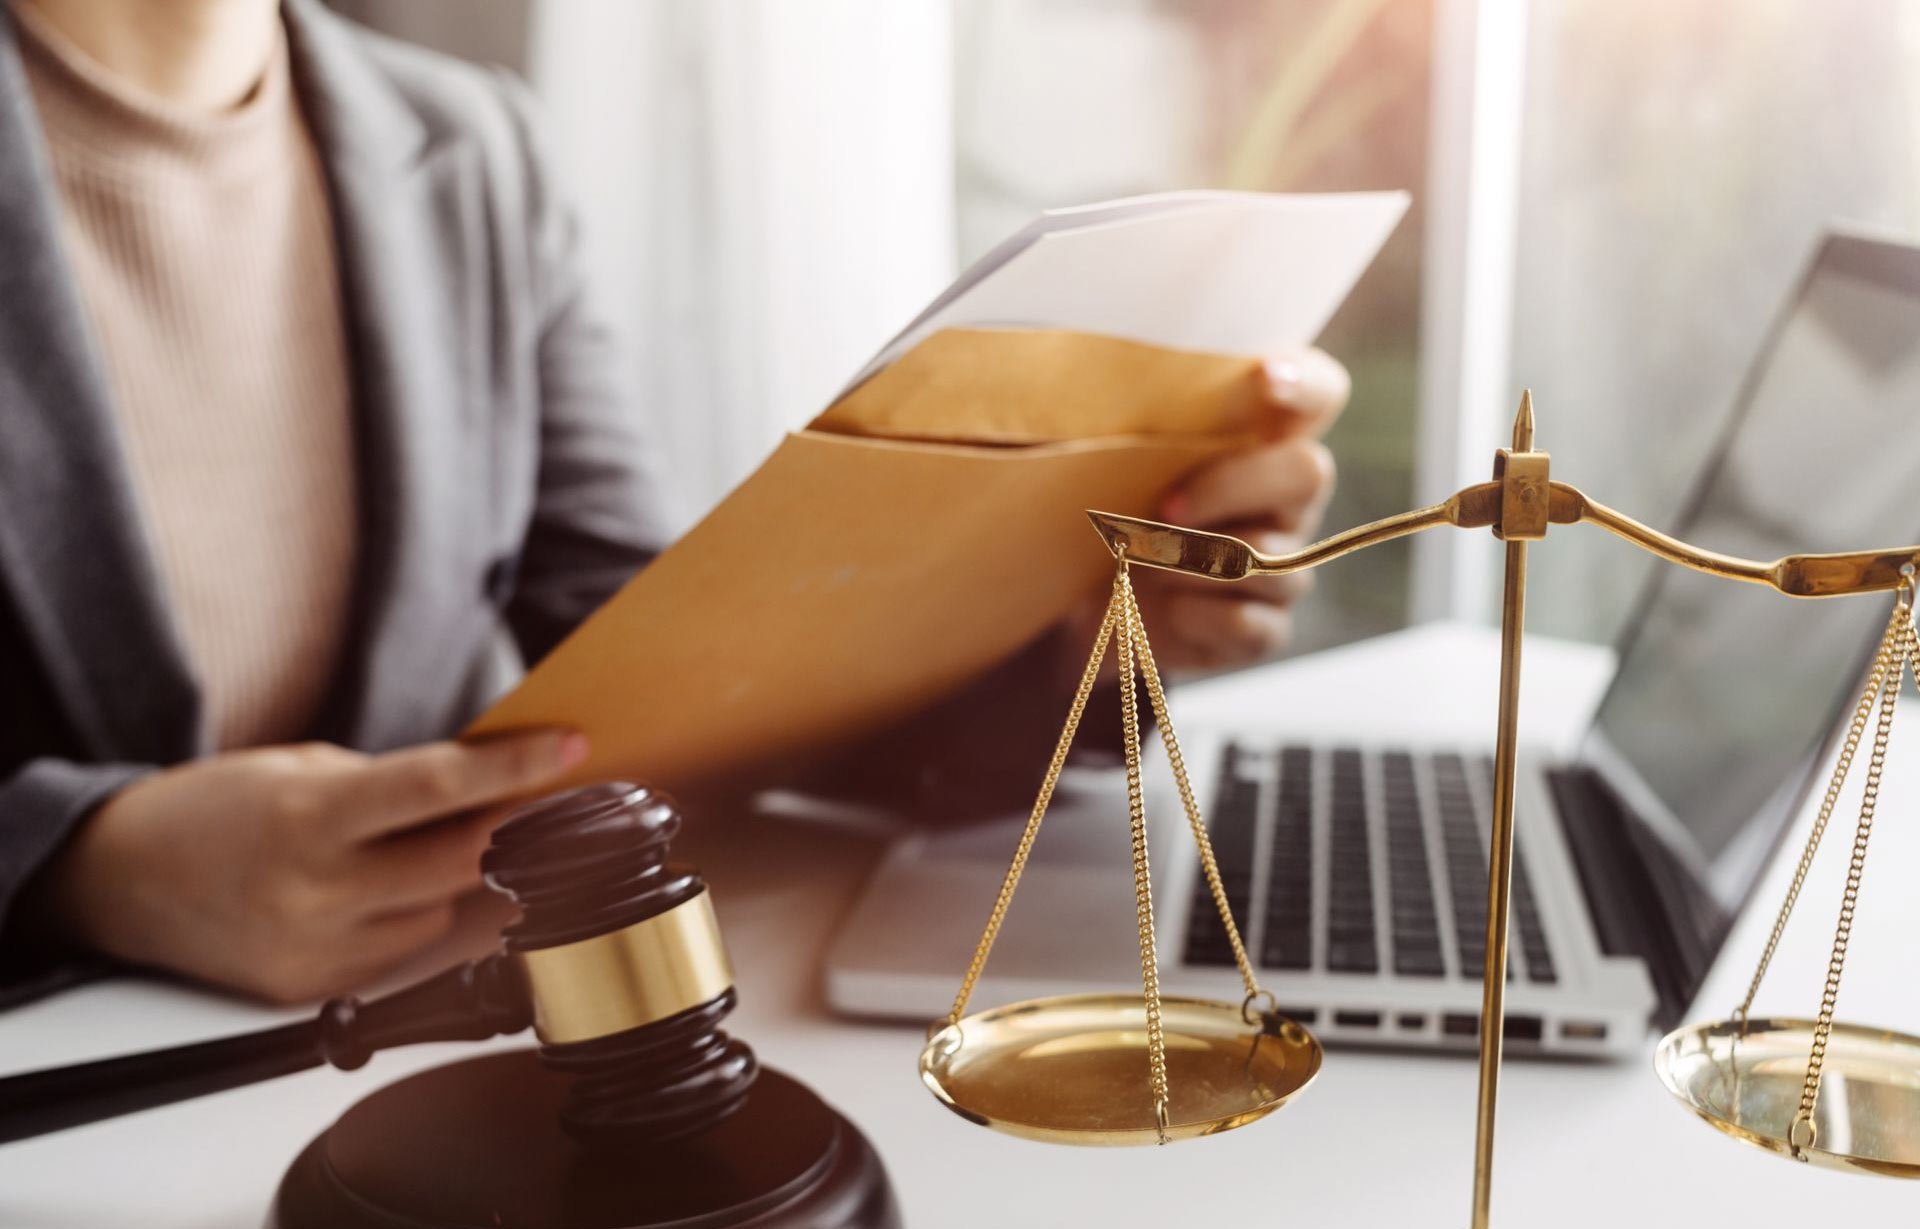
1653, 1018, 1920, 1177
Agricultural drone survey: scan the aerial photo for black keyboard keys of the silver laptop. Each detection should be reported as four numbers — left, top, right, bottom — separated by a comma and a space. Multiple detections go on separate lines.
1185, 743, 1557, 985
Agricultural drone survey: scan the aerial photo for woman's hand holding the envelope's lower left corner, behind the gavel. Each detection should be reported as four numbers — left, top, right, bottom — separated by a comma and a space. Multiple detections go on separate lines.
38, 730, 588, 1002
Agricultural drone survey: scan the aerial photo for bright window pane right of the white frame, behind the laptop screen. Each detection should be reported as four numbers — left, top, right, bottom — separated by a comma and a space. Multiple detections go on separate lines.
1513, 0, 1920, 639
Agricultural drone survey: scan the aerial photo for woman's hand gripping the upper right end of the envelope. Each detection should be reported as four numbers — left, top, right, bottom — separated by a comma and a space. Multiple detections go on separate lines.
1133, 349, 1352, 670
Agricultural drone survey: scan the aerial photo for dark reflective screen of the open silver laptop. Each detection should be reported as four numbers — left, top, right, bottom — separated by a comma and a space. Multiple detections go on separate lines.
1582, 236, 1920, 997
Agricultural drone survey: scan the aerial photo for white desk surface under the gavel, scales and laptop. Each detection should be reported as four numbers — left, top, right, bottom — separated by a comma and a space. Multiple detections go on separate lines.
0, 628, 1920, 1229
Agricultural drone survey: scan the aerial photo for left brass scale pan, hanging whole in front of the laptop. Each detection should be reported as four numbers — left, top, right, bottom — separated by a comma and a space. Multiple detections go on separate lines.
920, 995, 1321, 1146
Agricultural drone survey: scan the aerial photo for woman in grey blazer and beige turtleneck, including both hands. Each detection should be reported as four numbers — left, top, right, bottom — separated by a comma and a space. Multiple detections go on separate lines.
0, 0, 1346, 1000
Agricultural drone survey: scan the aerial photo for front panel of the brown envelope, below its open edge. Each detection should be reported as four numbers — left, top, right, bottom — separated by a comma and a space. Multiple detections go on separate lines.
472, 432, 1223, 787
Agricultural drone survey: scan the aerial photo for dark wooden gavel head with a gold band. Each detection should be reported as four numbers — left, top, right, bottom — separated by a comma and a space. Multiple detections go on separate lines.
480, 782, 758, 1146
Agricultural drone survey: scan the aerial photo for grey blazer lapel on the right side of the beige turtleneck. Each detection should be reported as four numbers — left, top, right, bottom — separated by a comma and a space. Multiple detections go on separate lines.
284, 0, 488, 749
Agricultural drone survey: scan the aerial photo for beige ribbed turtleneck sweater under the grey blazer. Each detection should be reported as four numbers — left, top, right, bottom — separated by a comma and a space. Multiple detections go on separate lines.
13, 4, 357, 749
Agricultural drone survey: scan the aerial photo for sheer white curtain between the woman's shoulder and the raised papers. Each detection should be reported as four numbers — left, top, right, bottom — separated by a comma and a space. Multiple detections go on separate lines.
526, 0, 956, 520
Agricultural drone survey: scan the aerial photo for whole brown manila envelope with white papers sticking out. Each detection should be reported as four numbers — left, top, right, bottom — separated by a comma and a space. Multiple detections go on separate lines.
467, 328, 1261, 789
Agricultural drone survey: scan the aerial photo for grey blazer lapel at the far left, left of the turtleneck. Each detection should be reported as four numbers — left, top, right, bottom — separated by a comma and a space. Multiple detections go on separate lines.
0, 8, 202, 764
